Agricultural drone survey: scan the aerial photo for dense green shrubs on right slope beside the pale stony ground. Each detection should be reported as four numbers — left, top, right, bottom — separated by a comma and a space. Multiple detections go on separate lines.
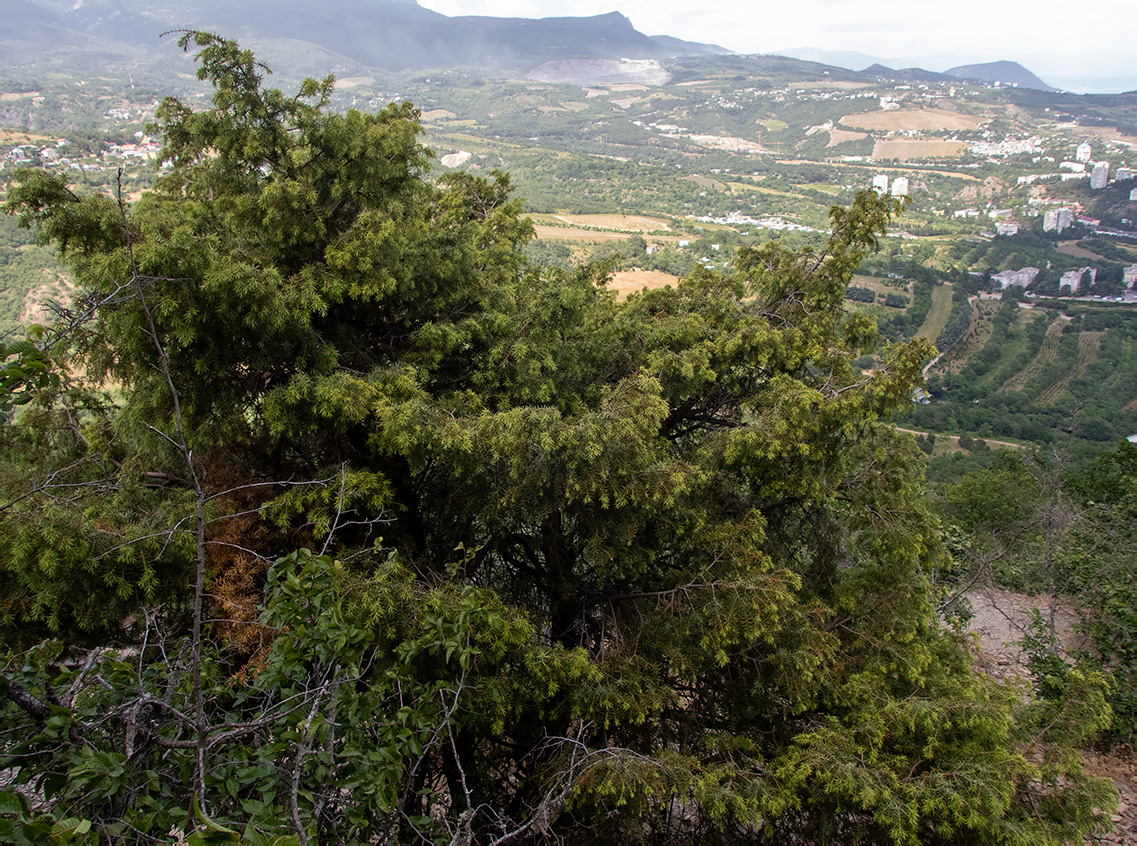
941, 438, 1137, 744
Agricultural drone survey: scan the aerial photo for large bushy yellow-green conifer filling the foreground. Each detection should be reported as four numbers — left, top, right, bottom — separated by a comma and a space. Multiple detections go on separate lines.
0, 33, 1110, 844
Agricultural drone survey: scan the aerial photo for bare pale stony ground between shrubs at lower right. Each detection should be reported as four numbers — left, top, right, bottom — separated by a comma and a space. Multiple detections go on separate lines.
968, 588, 1137, 846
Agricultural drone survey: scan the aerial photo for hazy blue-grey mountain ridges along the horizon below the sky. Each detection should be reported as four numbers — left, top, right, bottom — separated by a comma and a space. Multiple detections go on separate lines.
0, 0, 1109, 91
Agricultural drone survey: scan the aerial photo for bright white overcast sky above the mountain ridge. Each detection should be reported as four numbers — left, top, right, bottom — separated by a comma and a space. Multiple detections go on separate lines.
418, 0, 1137, 87
